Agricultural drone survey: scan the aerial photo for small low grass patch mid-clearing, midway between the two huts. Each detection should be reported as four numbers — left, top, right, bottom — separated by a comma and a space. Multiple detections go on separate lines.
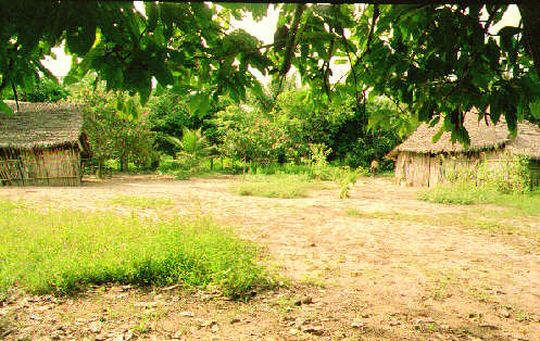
232, 175, 317, 199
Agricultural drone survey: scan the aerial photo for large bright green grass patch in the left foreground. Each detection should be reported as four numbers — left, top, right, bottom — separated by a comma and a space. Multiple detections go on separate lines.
0, 201, 269, 298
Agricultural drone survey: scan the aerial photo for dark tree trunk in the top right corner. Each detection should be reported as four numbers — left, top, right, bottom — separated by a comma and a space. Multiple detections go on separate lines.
518, 1, 540, 75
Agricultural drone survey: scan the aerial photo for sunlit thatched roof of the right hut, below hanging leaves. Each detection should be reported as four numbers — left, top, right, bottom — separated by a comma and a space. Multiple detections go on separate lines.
388, 111, 540, 159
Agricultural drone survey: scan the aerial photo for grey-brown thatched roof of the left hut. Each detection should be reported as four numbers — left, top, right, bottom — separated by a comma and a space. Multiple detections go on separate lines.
0, 101, 83, 149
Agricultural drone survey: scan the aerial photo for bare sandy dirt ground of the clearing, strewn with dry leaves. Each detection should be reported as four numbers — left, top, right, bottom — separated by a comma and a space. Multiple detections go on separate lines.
0, 177, 540, 340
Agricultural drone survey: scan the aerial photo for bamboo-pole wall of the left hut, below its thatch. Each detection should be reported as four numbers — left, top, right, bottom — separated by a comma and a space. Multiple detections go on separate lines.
0, 146, 81, 186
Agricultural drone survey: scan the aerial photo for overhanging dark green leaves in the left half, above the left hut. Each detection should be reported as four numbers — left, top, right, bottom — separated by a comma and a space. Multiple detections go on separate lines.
0, 0, 269, 111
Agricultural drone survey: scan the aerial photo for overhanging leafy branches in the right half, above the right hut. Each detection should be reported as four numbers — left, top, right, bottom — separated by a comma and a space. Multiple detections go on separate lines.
277, 2, 540, 143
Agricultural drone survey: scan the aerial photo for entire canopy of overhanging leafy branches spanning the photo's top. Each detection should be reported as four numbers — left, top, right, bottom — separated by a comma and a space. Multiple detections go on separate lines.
0, 0, 540, 143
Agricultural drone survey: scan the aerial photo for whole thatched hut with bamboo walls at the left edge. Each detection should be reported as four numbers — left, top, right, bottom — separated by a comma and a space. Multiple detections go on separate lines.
0, 101, 88, 186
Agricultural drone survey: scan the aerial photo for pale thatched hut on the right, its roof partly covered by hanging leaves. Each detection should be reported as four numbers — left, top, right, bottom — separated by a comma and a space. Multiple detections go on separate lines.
387, 112, 540, 186
